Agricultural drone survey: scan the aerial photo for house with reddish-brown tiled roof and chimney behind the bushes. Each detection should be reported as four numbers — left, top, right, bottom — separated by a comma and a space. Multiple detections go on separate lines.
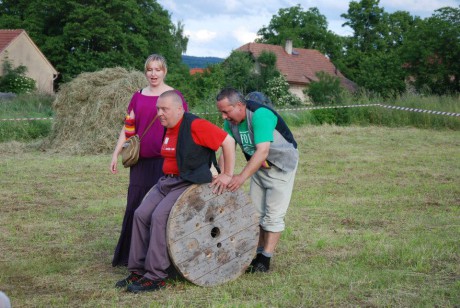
236, 40, 357, 100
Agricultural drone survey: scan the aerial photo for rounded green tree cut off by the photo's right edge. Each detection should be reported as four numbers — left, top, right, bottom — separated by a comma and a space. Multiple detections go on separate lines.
401, 6, 460, 95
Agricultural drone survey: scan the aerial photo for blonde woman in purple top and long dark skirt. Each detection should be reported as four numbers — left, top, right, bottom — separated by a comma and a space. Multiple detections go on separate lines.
110, 54, 188, 266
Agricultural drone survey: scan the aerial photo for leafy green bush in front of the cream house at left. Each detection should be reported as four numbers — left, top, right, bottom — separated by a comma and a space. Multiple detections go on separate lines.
0, 58, 36, 94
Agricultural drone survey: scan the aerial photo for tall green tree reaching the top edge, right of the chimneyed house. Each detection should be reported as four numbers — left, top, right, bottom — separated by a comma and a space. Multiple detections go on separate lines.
338, 0, 418, 98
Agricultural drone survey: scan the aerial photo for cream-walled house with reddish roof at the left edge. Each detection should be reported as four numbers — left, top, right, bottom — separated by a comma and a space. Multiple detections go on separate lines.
0, 29, 59, 94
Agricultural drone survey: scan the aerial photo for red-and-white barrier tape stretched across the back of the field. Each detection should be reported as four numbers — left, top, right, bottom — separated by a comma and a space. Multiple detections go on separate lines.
0, 104, 460, 121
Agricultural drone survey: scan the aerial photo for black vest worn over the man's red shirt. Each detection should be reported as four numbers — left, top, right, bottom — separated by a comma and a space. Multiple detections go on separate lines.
176, 112, 220, 184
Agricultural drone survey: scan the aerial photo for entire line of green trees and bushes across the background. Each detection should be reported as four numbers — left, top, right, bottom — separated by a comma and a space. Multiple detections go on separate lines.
0, 0, 460, 106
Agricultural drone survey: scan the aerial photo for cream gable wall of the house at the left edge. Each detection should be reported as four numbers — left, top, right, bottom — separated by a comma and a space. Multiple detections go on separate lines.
0, 33, 57, 94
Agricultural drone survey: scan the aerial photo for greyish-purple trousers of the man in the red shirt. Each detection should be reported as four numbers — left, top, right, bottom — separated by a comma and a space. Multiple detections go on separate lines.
128, 176, 191, 280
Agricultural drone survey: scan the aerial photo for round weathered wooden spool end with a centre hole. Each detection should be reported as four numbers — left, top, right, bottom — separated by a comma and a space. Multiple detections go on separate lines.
166, 184, 259, 286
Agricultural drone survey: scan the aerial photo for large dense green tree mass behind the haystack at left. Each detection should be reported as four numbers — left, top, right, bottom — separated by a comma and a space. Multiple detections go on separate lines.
0, 0, 187, 81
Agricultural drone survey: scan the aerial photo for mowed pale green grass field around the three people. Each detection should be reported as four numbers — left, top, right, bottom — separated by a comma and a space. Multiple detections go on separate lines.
0, 126, 460, 307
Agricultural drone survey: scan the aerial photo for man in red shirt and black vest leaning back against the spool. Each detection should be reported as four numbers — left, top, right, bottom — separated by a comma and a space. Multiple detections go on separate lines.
115, 91, 235, 293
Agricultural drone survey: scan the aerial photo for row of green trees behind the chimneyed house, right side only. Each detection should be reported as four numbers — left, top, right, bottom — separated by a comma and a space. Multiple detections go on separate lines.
258, 0, 460, 97
